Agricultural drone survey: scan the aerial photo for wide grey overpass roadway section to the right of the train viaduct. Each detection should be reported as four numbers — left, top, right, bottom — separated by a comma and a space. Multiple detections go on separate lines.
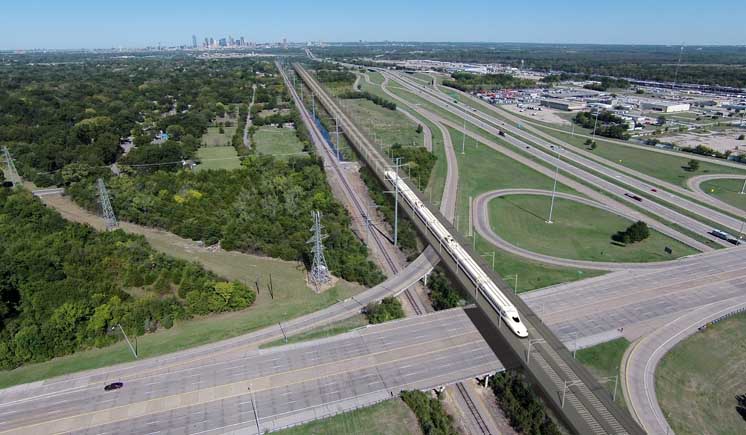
522, 248, 746, 347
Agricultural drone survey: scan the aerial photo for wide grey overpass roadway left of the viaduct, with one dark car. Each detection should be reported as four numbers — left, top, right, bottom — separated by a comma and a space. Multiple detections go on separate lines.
0, 309, 501, 434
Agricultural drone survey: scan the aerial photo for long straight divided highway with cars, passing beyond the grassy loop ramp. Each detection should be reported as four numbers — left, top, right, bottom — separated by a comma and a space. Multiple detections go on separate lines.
388, 73, 740, 246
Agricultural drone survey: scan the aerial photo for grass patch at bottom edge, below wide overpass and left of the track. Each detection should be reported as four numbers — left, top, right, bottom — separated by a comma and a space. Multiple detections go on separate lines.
274, 399, 422, 435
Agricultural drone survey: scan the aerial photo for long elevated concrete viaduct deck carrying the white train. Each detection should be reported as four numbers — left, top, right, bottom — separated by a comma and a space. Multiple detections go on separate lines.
294, 64, 644, 435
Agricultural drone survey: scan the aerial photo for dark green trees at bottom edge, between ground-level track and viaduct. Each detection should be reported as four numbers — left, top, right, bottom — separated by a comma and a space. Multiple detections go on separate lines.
490, 371, 561, 435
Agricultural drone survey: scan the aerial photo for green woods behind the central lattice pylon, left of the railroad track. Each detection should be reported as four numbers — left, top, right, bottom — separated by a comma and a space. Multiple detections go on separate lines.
65, 156, 383, 285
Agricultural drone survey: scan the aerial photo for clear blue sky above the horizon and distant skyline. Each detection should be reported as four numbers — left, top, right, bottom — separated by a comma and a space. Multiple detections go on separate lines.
0, 0, 746, 49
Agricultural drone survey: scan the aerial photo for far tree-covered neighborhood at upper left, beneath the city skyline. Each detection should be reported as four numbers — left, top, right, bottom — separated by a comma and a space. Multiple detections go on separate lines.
0, 55, 276, 185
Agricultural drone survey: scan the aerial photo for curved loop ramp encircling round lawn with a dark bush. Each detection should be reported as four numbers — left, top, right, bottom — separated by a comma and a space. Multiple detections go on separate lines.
472, 189, 688, 270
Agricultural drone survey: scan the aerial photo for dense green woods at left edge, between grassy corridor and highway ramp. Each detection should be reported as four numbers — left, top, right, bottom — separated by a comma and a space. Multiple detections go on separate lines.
0, 189, 256, 369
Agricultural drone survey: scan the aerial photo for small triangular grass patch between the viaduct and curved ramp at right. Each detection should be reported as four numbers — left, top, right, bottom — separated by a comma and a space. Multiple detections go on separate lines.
575, 338, 630, 409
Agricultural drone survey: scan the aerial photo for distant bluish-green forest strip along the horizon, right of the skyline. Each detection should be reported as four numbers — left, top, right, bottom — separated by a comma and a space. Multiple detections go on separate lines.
314, 43, 746, 88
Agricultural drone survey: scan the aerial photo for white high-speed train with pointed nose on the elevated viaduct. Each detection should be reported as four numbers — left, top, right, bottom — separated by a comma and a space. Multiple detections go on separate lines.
385, 171, 528, 338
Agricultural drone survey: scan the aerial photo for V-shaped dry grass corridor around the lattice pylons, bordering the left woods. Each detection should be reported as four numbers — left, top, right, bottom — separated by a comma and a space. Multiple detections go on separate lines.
0, 196, 363, 388
